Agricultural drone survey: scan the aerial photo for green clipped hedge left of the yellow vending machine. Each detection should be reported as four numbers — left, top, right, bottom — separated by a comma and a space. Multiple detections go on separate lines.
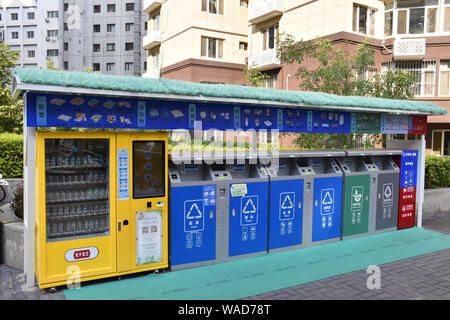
0, 133, 23, 178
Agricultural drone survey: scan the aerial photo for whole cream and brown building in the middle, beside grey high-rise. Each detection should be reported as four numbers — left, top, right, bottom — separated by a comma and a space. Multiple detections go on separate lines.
143, 0, 248, 84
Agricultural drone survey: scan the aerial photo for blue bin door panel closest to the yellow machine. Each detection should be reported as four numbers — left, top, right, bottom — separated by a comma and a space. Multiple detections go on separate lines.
170, 185, 216, 265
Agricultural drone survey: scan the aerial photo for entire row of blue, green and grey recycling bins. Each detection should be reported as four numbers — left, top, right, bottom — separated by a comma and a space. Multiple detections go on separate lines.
169, 150, 418, 270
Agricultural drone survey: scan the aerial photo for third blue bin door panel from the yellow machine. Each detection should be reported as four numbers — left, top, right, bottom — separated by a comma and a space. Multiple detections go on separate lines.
269, 180, 303, 249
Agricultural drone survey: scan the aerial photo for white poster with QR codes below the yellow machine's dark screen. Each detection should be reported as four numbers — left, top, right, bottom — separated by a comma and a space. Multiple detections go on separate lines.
136, 210, 163, 266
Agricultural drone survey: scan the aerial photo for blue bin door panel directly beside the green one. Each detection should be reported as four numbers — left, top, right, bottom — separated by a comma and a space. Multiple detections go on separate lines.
312, 177, 342, 242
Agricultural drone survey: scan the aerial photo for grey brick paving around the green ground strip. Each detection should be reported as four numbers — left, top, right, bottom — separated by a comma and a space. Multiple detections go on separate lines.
0, 213, 450, 300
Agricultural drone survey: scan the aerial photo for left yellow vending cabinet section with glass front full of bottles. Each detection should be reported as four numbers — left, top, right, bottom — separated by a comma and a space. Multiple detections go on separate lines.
36, 133, 117, 288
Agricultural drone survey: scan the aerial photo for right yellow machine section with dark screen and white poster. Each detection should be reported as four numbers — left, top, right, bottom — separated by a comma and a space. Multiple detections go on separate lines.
117, 133, 169, 274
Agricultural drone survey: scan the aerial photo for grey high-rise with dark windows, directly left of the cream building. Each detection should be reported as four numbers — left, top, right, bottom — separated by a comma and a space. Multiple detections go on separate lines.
60, 0, 147, 76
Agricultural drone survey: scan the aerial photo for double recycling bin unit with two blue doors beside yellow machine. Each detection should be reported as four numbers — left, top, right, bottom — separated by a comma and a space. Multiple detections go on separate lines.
169, 155, 268, 270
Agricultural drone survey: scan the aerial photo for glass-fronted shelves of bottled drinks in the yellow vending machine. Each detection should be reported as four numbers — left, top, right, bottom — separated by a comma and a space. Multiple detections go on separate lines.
45, 139, 109, 242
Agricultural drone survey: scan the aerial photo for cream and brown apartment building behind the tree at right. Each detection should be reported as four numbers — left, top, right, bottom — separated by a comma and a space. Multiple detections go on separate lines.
248, 0, 450, 155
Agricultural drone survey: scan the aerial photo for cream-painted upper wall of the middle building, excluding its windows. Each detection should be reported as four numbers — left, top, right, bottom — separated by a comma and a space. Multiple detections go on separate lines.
148, 0, 248, 68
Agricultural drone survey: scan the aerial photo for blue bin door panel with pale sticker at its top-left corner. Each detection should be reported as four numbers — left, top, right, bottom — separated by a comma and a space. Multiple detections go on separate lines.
228, 182, 269, 257
